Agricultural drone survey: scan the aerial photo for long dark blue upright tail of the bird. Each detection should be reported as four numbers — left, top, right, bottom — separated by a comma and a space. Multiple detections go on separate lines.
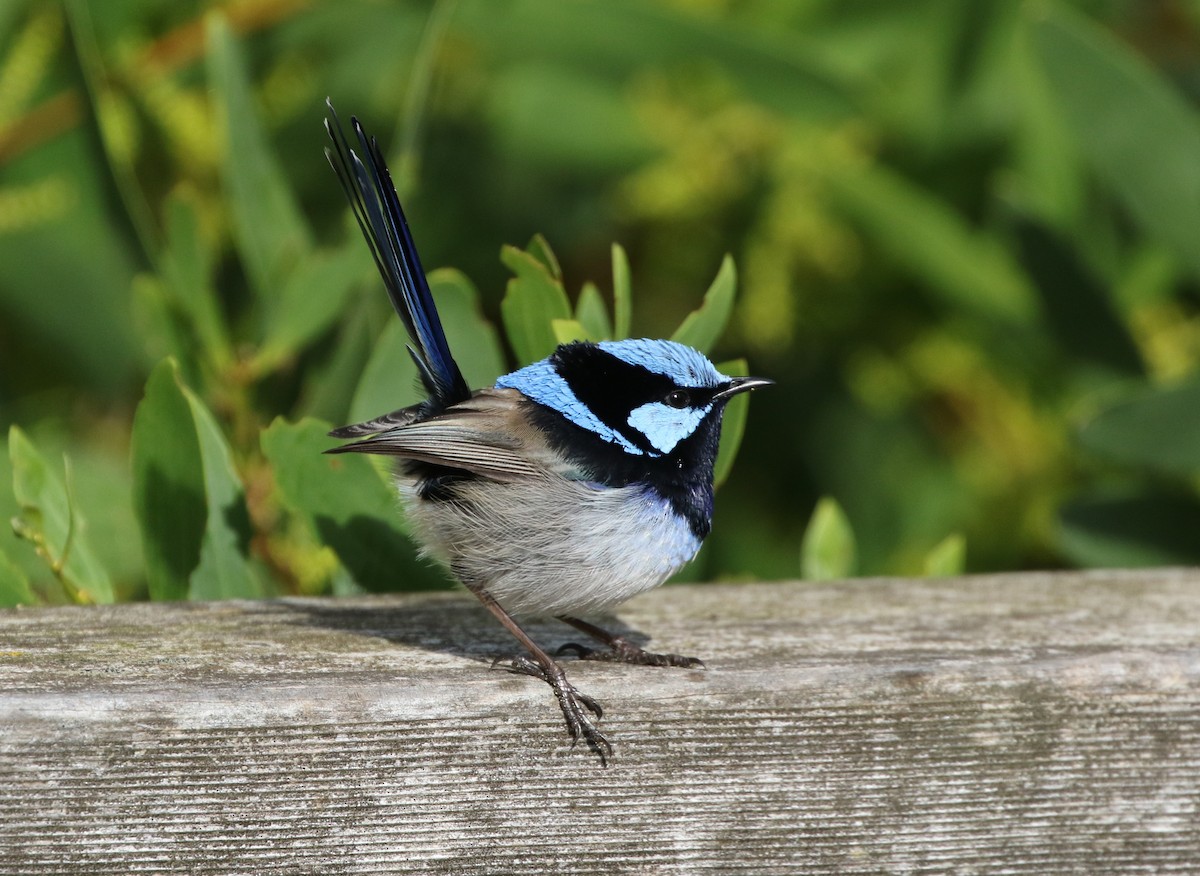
325, 98, 470, 409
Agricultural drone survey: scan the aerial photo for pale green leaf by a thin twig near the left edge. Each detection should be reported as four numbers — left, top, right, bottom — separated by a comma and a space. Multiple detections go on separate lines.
8, 426, 113, 602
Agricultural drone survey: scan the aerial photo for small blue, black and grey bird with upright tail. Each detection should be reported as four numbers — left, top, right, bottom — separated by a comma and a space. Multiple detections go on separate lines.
325, 101, 773, 766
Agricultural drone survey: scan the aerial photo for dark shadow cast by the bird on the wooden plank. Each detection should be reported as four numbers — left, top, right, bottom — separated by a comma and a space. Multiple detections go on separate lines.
280, 592, 649, 664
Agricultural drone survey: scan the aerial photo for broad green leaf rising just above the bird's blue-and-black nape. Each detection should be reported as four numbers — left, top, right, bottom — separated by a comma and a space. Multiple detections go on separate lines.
500, 246, 571, 365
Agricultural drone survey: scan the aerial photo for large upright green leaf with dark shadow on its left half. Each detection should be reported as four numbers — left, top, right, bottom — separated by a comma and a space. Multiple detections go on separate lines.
131, 359, 263, 599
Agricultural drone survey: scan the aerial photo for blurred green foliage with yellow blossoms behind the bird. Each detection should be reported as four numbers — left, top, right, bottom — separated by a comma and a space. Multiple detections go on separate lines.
0, 0, 1200, 604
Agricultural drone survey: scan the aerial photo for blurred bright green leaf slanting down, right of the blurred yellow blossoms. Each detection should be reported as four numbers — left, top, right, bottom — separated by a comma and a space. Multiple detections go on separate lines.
827, 166, 1038, 323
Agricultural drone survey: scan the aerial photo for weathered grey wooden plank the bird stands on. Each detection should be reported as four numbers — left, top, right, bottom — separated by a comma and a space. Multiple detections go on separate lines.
0, 570, 1200, 875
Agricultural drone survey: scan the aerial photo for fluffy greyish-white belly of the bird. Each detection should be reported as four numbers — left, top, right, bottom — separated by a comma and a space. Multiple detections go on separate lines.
398, 478, 700, 614
